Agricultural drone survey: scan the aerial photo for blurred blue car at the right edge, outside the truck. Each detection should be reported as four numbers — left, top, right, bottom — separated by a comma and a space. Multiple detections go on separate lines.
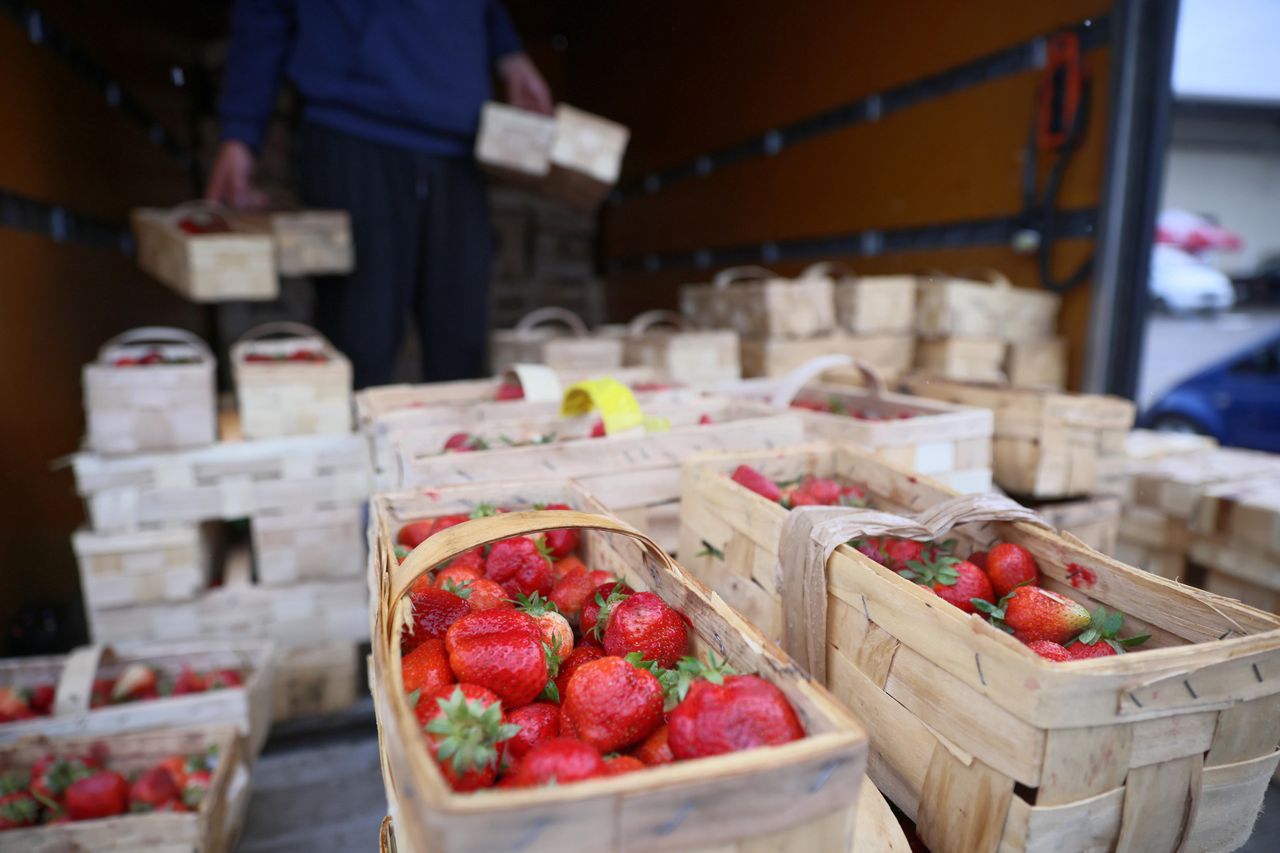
1139, 336, 1280, 452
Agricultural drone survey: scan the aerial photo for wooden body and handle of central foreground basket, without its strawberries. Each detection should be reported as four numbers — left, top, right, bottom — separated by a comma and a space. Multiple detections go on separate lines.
374, 494, 867, 853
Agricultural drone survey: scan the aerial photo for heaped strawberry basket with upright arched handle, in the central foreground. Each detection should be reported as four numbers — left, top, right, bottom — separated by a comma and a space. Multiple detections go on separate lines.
371, 483, 865, 850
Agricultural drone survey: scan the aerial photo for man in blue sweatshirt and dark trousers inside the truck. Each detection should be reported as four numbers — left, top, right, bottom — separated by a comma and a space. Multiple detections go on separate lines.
205, 0, 552, 387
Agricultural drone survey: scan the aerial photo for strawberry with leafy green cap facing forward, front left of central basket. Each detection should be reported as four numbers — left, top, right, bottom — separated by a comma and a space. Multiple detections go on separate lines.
425, 684, 520, 792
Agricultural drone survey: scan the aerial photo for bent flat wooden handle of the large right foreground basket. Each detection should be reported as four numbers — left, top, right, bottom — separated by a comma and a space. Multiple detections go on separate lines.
777, 494, 1053, 684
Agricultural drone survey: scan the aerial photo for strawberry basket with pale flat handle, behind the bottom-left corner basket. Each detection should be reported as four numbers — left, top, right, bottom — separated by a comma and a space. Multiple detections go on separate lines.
0, 640, 275, 761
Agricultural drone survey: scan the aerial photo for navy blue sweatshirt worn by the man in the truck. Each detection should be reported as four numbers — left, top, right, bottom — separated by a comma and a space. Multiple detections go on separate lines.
219, 0, 521, 156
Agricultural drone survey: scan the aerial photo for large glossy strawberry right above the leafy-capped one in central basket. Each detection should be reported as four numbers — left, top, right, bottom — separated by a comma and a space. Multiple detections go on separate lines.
444, 610, 549, 708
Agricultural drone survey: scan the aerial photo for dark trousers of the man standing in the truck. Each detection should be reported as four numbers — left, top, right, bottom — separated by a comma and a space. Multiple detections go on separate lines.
300, 124, 493, 388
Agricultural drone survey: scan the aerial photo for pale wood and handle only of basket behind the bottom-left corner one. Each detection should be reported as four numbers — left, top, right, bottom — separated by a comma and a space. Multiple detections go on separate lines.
0, 640, 276, 762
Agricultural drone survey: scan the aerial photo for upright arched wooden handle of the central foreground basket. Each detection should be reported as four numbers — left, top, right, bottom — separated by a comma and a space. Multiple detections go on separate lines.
383, 510, 684, 643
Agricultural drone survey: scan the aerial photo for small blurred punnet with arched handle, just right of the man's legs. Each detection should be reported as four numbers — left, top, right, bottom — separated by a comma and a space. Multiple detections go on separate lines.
492, 307, 622, 373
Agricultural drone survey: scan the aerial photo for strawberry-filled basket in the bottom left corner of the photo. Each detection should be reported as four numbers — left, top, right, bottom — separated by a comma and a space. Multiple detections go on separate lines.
0, 726, 248, 853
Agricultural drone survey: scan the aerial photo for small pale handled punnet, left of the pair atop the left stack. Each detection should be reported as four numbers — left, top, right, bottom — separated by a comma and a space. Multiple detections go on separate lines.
83, 327, 218, 453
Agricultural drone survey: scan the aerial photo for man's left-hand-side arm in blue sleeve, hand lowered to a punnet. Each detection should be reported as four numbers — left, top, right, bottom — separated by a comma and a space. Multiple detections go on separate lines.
205, 0, 294, 207
